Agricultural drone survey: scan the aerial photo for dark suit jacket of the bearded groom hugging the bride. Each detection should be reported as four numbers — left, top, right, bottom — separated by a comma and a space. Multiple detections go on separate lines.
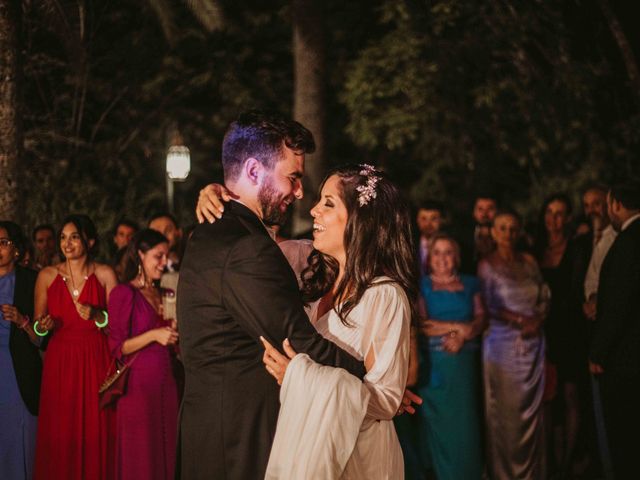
176, 202, 365, 480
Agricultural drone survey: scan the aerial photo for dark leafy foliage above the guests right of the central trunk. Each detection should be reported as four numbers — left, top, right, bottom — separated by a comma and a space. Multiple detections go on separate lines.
342, 0, 640, 221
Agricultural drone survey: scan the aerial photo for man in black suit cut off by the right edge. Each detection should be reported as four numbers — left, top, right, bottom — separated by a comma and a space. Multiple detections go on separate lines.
589, 184, 640, 479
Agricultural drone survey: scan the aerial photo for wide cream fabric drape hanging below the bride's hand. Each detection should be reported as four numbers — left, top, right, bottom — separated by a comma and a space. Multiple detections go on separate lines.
265, 353, 369, 480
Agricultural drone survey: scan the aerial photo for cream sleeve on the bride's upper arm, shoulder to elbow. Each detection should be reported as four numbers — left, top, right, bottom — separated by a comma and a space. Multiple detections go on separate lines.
361, 283, 411, 420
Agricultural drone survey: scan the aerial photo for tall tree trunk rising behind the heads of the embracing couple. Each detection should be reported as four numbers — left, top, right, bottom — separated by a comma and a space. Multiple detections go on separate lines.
292, 0, 326, 235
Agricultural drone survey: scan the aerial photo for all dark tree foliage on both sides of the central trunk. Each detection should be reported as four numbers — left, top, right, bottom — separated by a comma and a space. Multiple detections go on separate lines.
13, 0, 640, 248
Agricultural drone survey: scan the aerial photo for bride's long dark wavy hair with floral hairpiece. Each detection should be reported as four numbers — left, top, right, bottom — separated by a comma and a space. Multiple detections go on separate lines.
301, 165, 418, 325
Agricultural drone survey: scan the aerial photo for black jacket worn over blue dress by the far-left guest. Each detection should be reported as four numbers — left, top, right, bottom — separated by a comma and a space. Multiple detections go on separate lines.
9, 266, 42, 415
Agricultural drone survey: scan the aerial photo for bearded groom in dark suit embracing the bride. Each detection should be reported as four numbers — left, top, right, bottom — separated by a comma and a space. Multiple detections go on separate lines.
176, 112, 365, 480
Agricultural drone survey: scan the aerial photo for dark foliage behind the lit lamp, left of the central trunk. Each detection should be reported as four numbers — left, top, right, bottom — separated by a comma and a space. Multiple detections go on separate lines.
23, 0, 292, 253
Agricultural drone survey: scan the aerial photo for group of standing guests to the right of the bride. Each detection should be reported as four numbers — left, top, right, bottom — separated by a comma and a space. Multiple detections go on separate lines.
396, 183, 640, 480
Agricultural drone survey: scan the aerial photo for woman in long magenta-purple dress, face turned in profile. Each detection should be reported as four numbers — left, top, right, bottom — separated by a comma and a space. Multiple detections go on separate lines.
109, 229, 178, 480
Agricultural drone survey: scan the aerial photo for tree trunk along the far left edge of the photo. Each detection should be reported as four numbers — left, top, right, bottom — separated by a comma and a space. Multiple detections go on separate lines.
0, 0, 22, 222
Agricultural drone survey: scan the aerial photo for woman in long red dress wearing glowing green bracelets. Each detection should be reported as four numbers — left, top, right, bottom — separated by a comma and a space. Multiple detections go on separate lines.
34, 215, 117, 480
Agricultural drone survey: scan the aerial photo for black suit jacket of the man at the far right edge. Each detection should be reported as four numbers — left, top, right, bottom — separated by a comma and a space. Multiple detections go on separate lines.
590, 219, 640, 377
